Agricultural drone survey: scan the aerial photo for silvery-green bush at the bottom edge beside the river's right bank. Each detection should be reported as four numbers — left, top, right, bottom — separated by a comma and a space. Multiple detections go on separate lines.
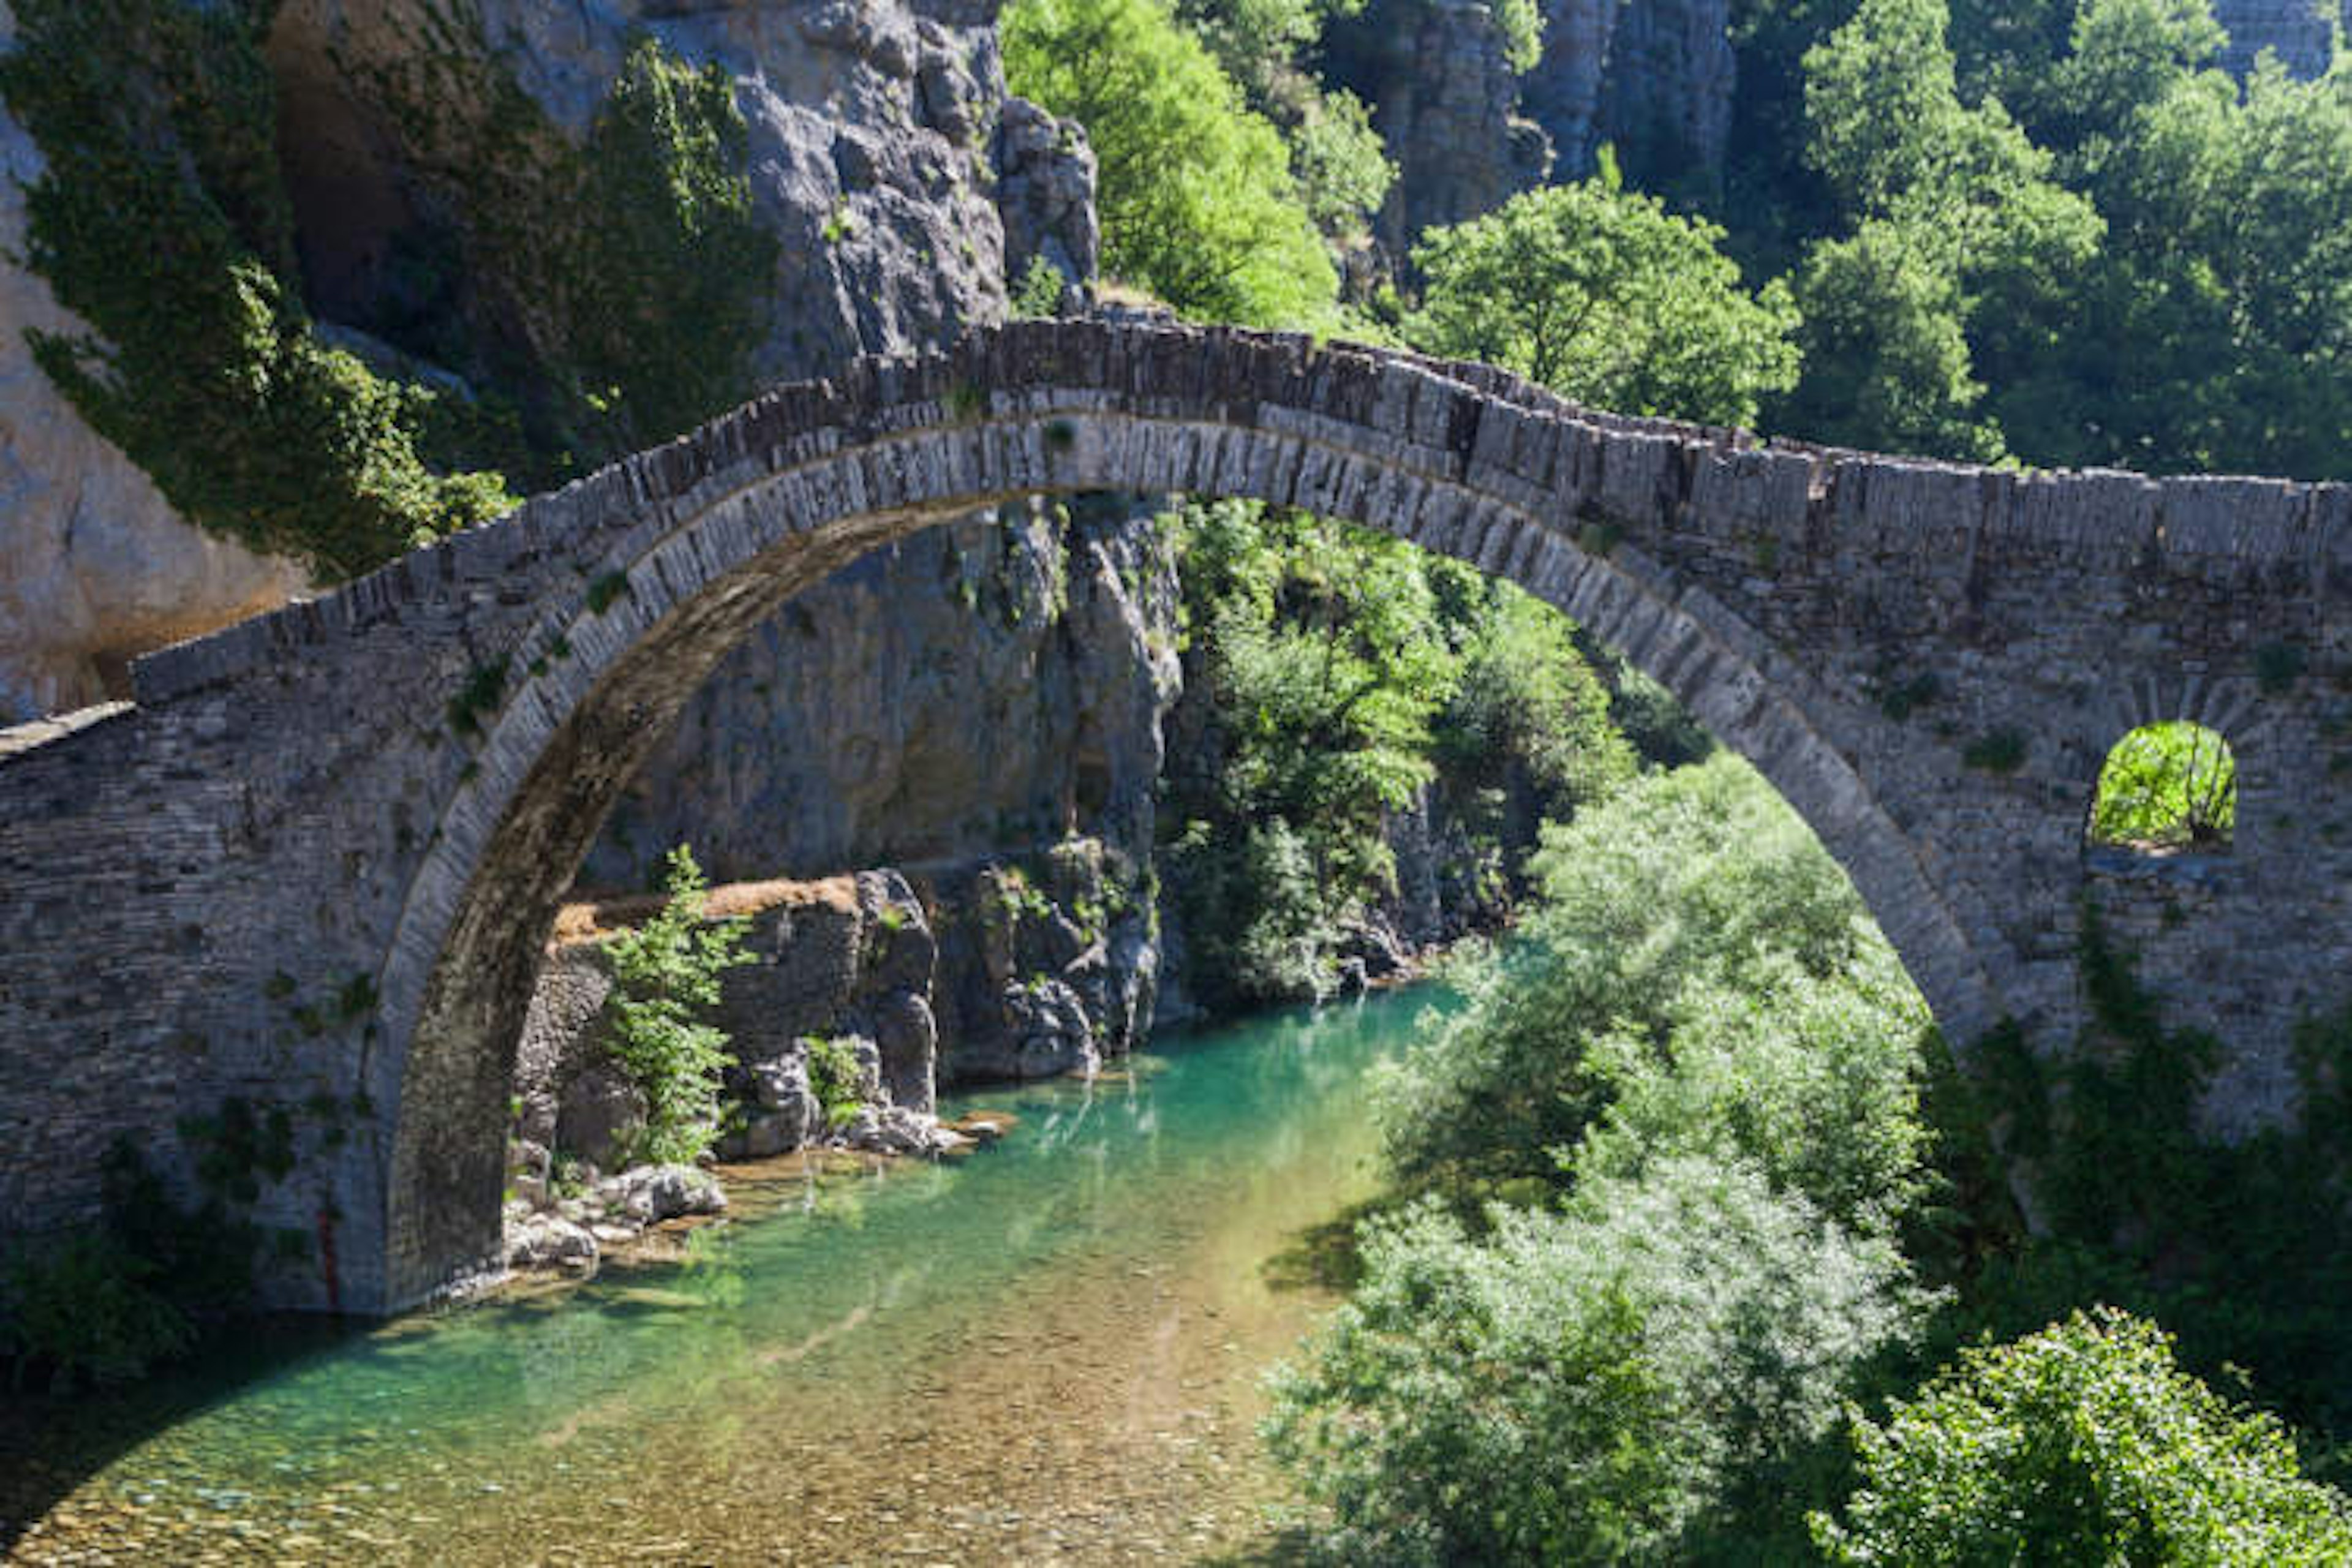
1265, 1156, 1910, 1566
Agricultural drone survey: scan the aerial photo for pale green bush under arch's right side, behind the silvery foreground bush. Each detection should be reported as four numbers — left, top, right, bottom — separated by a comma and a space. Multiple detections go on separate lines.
1378, 757, 1926, 1227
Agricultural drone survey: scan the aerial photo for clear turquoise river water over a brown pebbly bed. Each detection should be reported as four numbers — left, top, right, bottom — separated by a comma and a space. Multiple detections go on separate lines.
0, 992, 1430, 1563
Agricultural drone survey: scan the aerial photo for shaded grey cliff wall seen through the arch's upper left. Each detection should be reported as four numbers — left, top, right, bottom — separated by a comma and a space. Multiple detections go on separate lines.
581, 503, 1181, 889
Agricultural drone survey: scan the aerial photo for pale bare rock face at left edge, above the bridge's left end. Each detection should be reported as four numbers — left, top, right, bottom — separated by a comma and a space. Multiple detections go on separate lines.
0, 13, 308, 724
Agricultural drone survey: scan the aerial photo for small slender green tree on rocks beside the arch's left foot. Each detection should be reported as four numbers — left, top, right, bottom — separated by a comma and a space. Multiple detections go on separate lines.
605, 844, 750, 1164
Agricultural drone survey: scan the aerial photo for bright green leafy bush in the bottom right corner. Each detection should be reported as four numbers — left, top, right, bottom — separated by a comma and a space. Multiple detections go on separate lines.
1815, 1310, 2352, 1568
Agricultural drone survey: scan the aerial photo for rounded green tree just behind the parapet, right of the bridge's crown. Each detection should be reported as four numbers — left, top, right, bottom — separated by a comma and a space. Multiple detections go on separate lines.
1406, 162, 1797, 423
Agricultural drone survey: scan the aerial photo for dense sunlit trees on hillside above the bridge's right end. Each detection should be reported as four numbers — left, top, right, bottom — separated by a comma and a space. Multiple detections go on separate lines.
1727, 0, 2352, 477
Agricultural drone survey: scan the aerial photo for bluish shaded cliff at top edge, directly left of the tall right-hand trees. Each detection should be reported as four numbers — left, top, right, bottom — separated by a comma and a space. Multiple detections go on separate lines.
1521, 0, 1736, 183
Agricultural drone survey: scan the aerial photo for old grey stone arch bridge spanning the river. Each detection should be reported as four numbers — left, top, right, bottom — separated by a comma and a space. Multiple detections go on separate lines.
0, 322, 2352, 1312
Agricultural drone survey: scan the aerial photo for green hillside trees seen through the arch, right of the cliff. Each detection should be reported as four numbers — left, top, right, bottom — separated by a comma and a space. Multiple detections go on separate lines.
1162, 503, 1632, 1006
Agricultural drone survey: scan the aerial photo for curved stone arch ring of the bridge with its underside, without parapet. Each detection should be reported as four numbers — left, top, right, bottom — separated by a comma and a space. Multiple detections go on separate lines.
371, 393, 2002, 1310
